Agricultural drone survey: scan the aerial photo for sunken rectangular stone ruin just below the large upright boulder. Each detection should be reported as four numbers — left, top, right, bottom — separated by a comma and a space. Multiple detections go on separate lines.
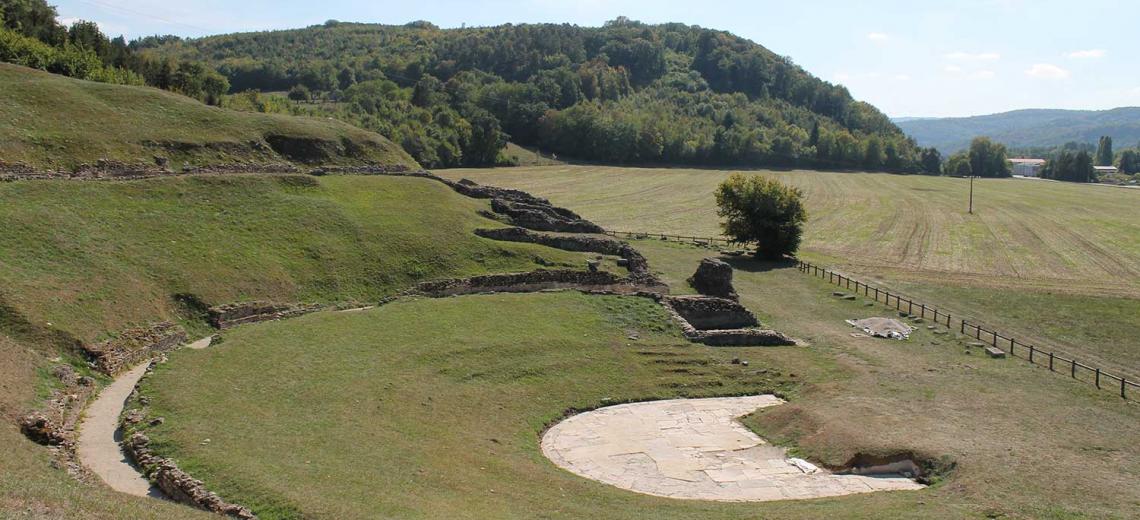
661, 296, 796, 347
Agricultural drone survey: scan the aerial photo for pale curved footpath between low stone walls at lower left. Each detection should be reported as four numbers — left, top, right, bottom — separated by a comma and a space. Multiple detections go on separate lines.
75, 338, 211, 498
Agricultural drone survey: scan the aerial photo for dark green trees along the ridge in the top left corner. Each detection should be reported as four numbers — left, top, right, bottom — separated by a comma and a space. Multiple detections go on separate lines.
0, 0, 230, 105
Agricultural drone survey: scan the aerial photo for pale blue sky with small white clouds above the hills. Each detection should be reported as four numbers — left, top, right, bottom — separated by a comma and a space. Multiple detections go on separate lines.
57, 0, 1140, 116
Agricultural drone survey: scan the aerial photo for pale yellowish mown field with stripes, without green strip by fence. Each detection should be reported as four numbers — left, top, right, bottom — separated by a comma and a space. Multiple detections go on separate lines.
440, 165, 1140, 296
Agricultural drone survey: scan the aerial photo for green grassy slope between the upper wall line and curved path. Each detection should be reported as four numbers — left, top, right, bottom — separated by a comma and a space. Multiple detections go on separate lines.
0, 174, 606, 519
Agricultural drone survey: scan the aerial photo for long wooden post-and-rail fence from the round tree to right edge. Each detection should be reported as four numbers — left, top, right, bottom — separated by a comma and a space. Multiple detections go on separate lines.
797, 261, 1140, 399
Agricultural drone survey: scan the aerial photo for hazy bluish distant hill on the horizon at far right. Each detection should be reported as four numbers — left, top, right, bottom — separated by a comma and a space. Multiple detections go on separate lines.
894, 107, 1140, 153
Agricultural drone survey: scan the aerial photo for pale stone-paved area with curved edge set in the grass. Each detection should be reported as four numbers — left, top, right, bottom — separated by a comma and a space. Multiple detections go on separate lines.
542, 396, 923, 502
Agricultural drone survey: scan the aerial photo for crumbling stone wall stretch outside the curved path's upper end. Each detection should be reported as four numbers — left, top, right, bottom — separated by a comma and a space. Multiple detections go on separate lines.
83, 322, 188, 375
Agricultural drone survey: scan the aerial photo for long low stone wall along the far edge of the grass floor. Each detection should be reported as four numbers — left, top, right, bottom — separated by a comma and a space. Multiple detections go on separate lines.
410, 269, 669, 296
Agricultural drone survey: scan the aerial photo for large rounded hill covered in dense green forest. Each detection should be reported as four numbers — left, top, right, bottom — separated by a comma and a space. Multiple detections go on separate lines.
140, 18, 919, 171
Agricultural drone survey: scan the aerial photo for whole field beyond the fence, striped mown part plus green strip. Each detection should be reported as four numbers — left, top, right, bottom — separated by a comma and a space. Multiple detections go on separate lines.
442, 166, 1140, 379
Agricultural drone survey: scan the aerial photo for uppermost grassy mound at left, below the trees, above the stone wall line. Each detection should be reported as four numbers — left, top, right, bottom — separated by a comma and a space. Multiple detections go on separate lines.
0, 63, 417, 170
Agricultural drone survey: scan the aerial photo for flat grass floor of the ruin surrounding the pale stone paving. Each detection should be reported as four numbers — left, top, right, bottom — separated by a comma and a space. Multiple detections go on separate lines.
145, 242, 1140, 519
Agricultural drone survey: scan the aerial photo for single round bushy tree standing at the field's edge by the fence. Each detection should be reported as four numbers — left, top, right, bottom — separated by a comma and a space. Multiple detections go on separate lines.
716, 173, 807, 260
